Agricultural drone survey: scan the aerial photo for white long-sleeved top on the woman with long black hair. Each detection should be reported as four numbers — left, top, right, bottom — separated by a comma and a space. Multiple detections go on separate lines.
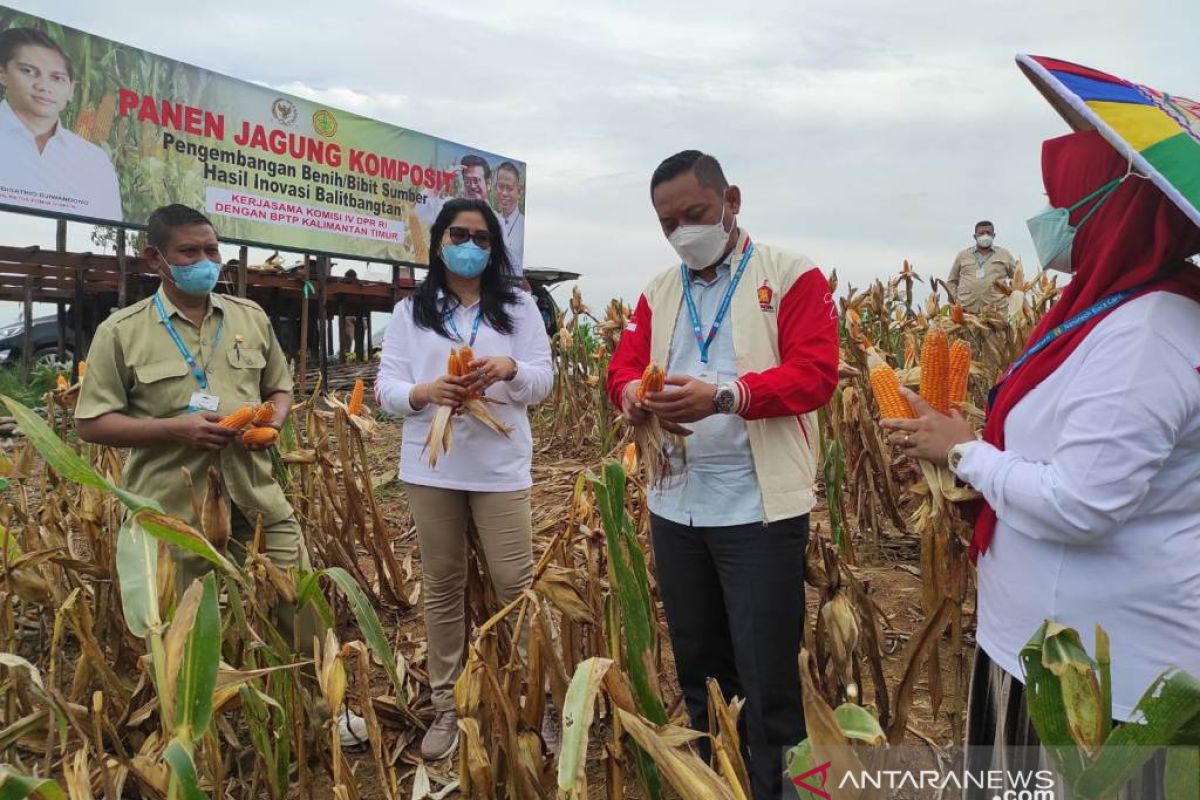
374, 293, 554, 492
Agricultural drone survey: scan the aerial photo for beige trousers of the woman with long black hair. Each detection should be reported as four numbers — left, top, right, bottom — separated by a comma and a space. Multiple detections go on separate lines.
404, 483, 533, 711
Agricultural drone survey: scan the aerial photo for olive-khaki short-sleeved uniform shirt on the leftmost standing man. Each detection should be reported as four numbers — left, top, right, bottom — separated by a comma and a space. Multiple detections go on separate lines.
76, 290, 292, 525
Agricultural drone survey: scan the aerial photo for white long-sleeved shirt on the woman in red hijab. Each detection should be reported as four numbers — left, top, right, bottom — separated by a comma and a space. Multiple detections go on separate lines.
958, 291, 1200, 720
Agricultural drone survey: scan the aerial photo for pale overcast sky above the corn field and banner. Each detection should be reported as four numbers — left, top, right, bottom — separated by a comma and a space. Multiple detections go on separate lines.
0, 0, 1200, 326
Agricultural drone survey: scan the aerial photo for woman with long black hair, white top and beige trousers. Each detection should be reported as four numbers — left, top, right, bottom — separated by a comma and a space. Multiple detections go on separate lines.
376, 199, 554, 760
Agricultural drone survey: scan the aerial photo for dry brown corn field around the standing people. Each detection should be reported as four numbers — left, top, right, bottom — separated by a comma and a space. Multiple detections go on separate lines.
0, 263, 1057, 800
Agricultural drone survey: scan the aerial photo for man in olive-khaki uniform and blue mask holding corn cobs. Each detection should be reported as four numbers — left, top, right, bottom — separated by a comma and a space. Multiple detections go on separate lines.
76, 204, 366, 744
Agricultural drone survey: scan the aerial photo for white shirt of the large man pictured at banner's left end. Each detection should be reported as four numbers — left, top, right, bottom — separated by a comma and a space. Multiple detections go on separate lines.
0, 101, 122, 222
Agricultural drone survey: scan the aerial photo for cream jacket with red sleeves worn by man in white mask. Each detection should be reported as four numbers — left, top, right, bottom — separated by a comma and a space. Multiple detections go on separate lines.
608, 227, 838, 523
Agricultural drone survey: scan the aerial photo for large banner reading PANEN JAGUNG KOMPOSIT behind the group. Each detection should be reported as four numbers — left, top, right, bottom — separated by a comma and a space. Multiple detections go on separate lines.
0, 6, 526, 271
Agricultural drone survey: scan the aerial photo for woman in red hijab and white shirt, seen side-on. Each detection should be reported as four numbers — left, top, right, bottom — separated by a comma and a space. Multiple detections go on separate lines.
884, 131, 1200, 798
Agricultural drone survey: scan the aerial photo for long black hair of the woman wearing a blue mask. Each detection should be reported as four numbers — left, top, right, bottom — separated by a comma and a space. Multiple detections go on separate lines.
413, 199, 517, 339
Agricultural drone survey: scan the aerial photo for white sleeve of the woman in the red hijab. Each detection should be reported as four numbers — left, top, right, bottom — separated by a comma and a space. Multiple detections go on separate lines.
958, 330, 1198, 545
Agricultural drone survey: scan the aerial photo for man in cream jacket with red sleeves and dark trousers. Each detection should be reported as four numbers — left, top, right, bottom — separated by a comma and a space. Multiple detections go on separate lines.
608, 150, 838, 800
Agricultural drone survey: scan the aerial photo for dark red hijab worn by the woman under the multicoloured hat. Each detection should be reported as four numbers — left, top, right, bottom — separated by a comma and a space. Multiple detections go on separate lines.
971, 131, 1200, 560
